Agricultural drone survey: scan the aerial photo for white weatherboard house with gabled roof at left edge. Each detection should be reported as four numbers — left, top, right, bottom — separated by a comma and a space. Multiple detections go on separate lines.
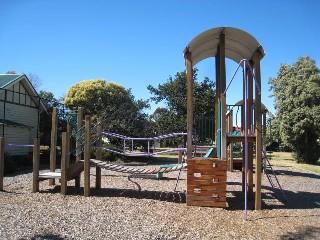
0, 74, 46, 155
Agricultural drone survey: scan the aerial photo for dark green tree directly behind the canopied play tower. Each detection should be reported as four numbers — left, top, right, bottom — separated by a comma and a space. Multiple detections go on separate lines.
147, 69, 215, 144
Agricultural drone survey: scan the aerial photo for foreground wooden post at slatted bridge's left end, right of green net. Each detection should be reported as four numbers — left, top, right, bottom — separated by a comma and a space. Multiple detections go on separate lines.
84, 115, 91, 197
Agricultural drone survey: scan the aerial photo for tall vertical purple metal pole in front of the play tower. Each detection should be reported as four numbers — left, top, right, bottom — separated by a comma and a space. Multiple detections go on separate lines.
243, 60, 249, 220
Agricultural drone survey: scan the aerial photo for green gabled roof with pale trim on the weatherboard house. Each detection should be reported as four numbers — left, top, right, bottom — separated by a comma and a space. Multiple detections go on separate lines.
0, 74, 47, 111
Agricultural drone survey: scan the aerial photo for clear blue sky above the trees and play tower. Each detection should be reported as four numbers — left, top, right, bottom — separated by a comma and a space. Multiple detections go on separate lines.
0, 0, 320, 115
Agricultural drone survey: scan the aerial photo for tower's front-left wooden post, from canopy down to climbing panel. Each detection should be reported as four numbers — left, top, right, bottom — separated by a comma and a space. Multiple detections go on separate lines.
184, 49, 193, 159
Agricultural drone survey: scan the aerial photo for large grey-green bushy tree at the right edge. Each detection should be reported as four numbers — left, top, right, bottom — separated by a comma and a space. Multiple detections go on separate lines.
269, 57, 320, 164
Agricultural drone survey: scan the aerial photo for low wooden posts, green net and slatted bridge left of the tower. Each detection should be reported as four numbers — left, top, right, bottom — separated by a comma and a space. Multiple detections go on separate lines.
32, 108, 185, 196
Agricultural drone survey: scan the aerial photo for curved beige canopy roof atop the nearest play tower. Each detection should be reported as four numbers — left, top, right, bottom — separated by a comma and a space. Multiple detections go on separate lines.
185, 27, 264, 65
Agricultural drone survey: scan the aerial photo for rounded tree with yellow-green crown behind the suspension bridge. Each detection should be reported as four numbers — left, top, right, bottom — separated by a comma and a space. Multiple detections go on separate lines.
64, 79, 150, 141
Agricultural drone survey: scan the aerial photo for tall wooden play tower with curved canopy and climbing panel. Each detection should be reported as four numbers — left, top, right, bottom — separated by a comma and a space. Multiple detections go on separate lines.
184, 27, 264, 209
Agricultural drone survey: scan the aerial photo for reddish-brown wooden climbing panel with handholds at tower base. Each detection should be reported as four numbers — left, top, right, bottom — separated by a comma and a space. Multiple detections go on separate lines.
187, 158, 227, 208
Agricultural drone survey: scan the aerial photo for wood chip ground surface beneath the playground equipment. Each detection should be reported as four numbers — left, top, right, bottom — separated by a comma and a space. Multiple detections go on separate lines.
0, 162, 320, 240
